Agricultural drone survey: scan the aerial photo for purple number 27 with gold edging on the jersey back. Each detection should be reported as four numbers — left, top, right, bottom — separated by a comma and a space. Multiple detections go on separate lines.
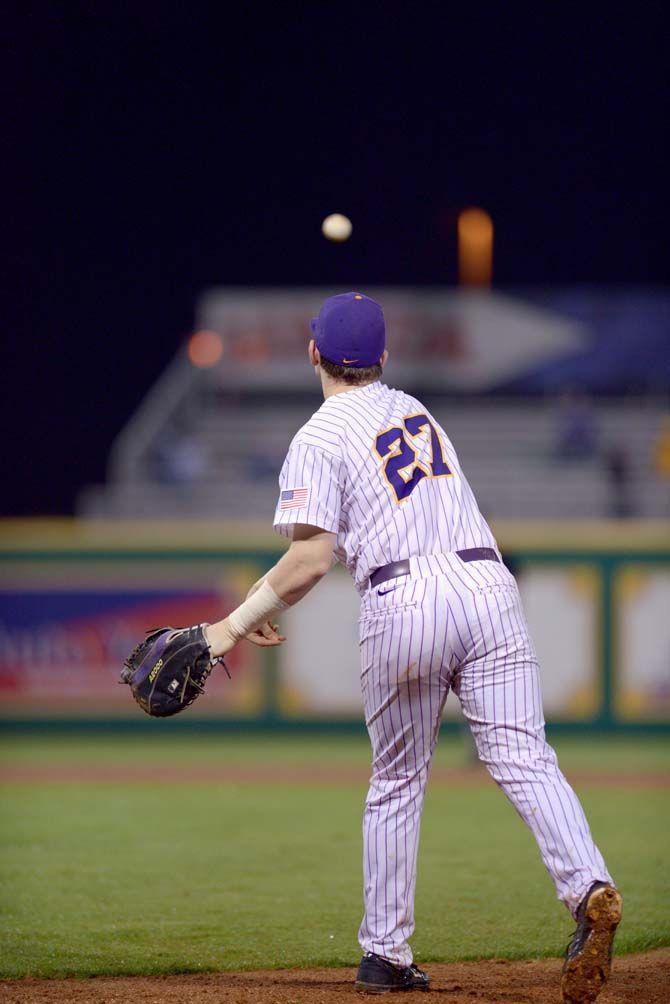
375, 415, 451, 502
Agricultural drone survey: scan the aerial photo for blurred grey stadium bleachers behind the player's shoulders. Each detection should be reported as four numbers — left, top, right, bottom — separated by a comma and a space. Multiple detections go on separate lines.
79, 391, 670, 519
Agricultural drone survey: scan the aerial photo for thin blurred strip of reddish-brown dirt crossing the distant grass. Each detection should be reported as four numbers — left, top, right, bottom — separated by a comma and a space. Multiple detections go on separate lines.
0, 762, 670, 788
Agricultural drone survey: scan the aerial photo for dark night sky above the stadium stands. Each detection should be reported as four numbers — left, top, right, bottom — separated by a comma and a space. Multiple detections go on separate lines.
2, 0, 669, 514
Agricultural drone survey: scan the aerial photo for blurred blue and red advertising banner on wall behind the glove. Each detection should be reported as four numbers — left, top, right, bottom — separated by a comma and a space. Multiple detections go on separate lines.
0, 561, 263, 718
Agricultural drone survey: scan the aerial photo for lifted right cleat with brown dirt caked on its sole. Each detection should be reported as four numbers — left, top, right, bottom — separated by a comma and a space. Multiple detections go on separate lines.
561, 882, 622, 1004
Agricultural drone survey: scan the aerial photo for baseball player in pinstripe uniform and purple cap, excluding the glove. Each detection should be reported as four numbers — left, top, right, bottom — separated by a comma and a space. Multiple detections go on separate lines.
207, 292, 622, 1002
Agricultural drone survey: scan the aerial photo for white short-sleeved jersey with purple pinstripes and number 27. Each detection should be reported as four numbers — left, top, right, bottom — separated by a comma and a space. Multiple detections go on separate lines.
274, 381, 497, 592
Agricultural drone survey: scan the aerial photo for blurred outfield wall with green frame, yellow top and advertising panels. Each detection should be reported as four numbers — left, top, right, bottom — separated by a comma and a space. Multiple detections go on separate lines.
0, 520, 670, 731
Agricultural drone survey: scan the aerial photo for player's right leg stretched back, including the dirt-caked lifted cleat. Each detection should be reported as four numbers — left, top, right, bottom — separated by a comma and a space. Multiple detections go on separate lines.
452, 568, 621, 1004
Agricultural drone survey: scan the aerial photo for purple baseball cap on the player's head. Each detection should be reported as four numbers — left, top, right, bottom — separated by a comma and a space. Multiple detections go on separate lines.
309, 293, 386, 369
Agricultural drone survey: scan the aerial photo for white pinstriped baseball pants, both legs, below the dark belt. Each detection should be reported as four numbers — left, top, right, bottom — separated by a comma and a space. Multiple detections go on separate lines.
359, 554, 612, 966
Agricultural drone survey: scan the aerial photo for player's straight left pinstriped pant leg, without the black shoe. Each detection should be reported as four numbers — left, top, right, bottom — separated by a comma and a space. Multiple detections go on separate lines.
359, 578, 449, 967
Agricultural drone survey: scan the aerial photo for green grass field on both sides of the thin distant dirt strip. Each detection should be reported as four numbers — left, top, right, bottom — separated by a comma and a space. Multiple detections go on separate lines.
0, 734, 670, 977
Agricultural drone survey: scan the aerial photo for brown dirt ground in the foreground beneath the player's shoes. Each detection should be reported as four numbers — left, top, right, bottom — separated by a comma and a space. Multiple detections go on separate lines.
0, 949, 670, 1004
